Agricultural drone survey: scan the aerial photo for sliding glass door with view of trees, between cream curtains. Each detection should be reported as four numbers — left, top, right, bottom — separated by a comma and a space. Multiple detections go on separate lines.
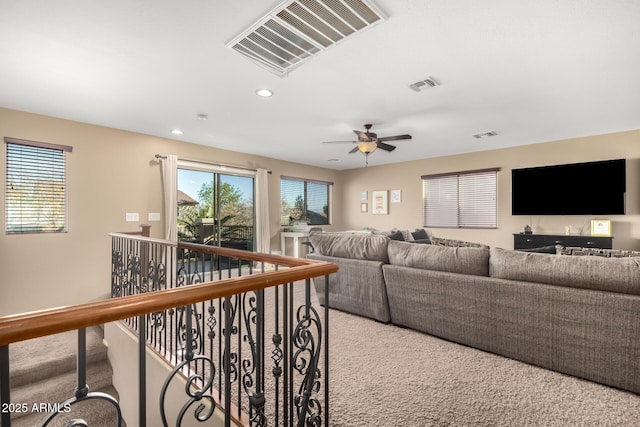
177, 164, 255, 251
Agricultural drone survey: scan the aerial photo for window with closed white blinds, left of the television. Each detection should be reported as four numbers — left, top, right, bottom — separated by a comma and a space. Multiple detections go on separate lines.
422, 169, 499, 228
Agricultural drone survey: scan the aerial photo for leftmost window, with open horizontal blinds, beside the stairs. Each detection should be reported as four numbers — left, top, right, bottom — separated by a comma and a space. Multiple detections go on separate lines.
4, 138, 72, 234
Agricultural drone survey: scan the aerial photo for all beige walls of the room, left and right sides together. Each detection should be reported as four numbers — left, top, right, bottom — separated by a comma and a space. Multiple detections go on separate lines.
0, 109, 640, 315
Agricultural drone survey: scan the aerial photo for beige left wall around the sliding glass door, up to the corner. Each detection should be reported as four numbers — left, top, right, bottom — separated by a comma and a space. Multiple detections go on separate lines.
0, 109, 339, 315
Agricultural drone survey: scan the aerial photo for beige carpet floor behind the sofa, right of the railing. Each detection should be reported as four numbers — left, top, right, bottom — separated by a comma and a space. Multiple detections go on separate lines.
322, 298, 640, 427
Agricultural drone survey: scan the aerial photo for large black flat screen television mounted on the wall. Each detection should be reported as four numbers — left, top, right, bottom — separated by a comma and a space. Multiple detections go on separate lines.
511, 159, 626, 215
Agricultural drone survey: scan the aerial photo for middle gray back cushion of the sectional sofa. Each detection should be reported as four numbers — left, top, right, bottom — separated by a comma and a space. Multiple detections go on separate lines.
388, 241, 489, 276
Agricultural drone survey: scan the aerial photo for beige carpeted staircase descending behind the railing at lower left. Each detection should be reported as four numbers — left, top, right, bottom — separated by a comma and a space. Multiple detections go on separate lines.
9, 327, 124, 427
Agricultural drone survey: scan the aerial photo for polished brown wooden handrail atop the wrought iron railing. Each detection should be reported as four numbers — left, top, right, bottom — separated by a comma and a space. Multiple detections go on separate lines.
0, 258, 338, 346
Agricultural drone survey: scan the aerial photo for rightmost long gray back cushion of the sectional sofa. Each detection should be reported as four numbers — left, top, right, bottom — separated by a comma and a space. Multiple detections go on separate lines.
489, 248, 640, 295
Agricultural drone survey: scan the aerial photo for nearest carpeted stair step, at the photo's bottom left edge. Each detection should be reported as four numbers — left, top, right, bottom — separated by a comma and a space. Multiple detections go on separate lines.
11, 386, 126, 427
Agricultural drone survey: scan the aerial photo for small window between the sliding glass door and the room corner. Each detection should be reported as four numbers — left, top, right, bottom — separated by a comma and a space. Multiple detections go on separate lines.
280, 176, 333, 225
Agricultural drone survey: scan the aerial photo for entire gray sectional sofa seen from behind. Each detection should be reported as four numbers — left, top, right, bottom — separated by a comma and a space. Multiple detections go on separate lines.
308, 233, 640, 394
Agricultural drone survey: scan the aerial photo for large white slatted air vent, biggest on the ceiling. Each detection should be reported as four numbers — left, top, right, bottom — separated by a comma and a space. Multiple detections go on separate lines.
226, 0, 385, 76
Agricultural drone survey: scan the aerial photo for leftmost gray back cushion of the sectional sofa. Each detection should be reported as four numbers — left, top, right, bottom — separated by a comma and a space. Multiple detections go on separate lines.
309, 233, 389, 263
